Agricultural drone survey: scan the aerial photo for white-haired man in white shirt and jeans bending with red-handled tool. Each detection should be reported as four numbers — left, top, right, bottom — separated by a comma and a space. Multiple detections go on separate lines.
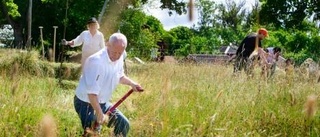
74, 33, 142, 137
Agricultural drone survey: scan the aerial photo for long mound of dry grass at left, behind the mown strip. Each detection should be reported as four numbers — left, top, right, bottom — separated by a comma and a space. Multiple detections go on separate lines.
0, 49, 81, 80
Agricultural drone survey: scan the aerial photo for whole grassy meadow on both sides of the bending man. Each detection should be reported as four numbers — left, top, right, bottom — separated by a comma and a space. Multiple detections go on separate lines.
0, 50, 320, 137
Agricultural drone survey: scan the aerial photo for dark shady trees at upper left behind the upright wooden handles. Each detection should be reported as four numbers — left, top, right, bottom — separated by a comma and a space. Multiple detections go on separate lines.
0, 0, 103, 48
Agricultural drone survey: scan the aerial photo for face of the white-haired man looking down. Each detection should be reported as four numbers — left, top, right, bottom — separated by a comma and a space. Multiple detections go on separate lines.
107, 42, 124, 62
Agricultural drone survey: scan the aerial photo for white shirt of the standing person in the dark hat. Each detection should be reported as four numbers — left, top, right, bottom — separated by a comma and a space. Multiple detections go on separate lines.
71, 30, 105, 65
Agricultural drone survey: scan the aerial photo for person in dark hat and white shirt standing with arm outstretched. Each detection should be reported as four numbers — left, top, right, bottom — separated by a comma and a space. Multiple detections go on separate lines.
64, 17, 105, 66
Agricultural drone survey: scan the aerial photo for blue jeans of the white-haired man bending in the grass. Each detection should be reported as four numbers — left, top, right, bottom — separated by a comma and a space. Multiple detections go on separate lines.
74, 96, 130, 137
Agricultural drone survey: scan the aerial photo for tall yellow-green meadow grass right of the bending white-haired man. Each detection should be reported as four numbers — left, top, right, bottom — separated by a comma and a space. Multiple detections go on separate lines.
128, 64, 320, 136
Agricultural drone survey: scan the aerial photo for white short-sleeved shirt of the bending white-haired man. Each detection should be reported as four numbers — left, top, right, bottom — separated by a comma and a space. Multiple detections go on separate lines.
76, 48, 124, 103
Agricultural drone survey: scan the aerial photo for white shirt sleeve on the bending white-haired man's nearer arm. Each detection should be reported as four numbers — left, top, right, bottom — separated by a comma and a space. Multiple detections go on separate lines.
83, 58, 102, 95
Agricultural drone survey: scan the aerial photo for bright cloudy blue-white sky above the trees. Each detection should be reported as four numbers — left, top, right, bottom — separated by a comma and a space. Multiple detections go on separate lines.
144, 0, 255, 30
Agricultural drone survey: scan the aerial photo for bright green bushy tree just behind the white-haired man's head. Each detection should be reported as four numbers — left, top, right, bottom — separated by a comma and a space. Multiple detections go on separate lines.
119, 9, 164, 59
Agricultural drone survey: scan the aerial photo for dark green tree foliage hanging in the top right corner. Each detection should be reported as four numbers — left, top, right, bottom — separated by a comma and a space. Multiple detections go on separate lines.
260, 0, 320, 29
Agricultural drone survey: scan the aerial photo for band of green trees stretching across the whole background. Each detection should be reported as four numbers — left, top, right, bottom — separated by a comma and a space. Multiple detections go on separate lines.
0, 0, 320, 60
